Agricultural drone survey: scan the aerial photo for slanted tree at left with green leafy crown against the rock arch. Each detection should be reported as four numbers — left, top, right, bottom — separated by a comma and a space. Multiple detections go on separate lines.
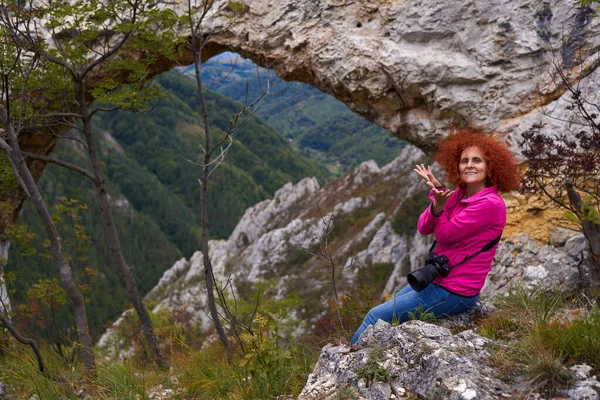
2, 0, 178, 365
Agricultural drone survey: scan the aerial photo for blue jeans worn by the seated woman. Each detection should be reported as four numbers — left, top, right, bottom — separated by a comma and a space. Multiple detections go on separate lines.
350, 284, 479, 344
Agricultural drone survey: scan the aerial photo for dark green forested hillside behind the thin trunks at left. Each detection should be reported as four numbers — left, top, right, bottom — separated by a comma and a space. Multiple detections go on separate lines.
8, 72, 327, 338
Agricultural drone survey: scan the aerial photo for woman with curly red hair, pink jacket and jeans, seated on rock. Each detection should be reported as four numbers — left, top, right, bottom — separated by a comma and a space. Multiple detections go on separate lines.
350, 129, 521, 344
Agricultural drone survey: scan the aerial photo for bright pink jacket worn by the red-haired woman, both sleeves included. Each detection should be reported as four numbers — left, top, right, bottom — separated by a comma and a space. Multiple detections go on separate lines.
417, 186, 506, 297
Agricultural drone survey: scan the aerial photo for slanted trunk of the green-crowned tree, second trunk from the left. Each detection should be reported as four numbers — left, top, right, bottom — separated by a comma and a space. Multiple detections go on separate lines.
75, 79, 166, 367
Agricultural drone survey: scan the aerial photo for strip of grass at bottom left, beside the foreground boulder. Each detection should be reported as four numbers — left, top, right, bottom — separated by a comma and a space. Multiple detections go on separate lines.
0, 324, 319, 400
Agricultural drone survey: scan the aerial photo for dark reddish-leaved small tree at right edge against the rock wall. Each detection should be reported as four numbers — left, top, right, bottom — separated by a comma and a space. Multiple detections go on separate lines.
520, 50, 600, 287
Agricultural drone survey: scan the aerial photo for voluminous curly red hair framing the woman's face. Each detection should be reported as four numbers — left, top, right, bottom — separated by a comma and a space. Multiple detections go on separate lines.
434, 128, 521, 192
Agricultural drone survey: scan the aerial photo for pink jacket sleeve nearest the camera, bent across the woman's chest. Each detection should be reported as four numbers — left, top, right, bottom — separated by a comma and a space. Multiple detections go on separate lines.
433, 197, 506, 245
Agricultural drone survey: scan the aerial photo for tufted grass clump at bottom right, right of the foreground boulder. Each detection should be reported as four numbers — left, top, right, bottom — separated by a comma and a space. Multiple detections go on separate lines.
477, 287, 600, 397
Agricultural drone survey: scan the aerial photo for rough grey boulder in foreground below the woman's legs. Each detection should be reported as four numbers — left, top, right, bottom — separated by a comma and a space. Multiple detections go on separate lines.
298, 321, 511, 400
